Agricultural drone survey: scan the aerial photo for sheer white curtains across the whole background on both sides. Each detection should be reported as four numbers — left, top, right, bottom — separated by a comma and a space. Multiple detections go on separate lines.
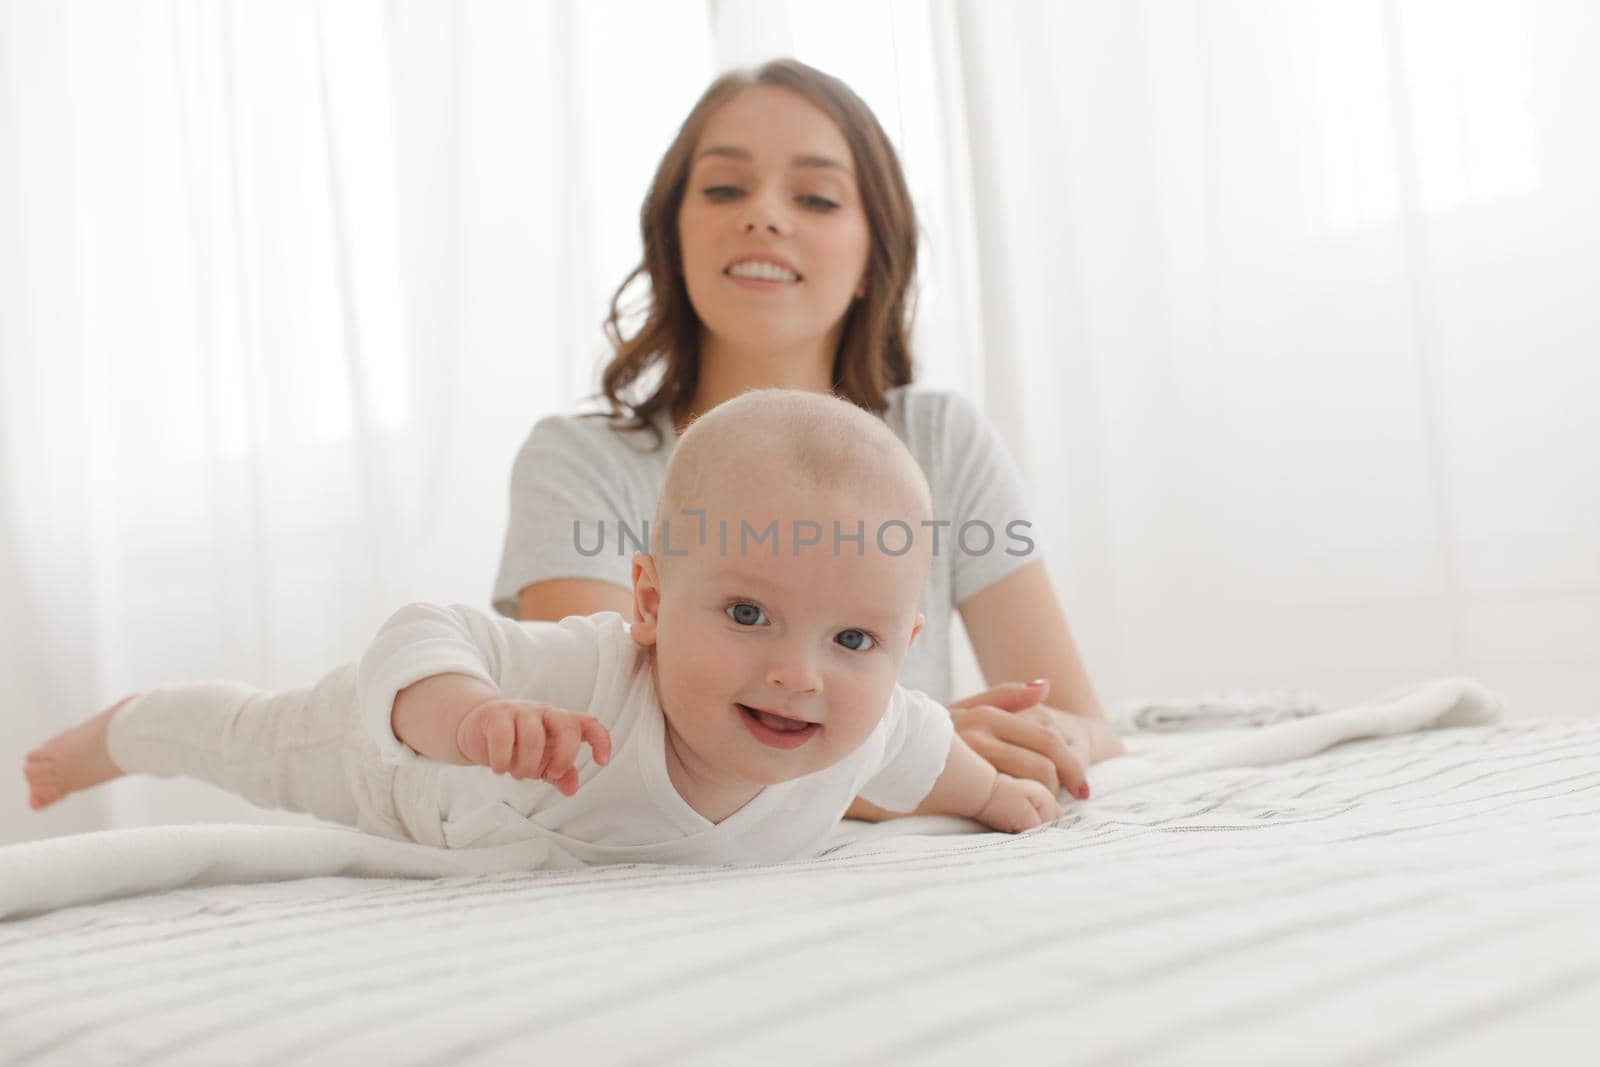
0, 0, 1600, 840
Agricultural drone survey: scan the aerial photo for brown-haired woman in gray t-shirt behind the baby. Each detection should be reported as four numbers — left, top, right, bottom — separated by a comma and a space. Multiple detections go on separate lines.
494, 59, 1122, 817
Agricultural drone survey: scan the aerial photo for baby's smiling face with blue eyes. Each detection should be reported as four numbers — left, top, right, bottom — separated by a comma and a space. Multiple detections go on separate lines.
634, 488, 926, 785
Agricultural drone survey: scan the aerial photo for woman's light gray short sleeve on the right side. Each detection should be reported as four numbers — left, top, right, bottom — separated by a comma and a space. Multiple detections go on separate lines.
936, 394, 1042, 605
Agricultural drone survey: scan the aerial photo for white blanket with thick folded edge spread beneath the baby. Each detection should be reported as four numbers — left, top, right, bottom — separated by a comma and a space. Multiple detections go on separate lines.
0, 678, 1501, 918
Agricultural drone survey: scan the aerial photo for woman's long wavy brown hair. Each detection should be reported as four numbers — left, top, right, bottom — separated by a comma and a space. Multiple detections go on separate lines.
598, 59, 917, 448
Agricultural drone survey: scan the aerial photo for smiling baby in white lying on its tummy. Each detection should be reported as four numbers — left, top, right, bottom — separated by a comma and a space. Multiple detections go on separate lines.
26, 390, 1061, 865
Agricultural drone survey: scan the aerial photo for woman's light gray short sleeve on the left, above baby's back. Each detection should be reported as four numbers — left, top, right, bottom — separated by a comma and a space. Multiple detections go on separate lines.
494, 416, 654, 619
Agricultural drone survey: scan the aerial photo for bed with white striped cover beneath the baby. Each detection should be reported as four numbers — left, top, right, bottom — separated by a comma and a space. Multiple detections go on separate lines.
0, 681, 1600, 1067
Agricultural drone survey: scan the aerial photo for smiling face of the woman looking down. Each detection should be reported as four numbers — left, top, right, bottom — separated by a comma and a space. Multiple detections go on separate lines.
678, 85, 870, 363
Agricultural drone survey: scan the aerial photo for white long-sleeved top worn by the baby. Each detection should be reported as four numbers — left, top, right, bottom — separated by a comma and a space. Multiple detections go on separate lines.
358, 605, 954, 865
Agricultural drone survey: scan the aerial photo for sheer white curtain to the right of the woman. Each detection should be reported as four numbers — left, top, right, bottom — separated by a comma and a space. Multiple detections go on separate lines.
752, 0, 1600, 715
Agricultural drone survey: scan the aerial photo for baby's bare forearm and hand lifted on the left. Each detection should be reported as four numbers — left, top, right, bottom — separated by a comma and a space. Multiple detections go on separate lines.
390, 673, 611, 797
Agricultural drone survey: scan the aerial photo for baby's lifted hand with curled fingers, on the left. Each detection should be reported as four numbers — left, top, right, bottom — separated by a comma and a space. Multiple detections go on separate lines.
456, 699, 611, 797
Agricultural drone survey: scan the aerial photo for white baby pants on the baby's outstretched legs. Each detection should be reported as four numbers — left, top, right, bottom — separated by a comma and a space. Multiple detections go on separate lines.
107, 664, 445, 848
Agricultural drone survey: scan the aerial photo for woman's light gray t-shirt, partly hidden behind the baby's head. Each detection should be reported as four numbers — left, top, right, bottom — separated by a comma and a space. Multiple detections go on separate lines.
494, 386, 1042, 702
